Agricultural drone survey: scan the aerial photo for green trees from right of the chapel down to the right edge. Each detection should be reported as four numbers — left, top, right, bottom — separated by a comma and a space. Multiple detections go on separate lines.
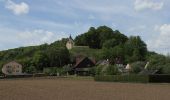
75, 26, 170, 74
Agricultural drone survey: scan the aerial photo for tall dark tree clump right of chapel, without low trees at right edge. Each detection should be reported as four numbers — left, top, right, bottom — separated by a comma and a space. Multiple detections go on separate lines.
75, 26, 147, 63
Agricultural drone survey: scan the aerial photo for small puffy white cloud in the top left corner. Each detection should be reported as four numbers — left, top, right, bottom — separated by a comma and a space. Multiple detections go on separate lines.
5, 0, 29, 15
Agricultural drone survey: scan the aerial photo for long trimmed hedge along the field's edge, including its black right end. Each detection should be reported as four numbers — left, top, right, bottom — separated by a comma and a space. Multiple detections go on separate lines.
94, 75, 170, 83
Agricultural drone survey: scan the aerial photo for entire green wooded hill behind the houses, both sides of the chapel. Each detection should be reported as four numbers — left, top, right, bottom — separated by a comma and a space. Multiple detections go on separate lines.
0, 26, 170, 73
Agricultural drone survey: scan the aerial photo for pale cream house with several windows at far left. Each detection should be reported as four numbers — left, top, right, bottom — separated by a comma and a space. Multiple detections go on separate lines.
2, 61, 22, 75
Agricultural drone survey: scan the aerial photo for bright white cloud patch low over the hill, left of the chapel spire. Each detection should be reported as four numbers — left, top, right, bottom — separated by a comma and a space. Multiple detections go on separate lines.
17, 29, 65, 46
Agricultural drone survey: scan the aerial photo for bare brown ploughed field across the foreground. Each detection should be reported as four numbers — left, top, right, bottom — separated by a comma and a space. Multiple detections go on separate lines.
0, 79, 170, 100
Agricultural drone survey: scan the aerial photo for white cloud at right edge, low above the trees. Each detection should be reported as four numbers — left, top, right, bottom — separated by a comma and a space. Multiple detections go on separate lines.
148, 24, 170, 54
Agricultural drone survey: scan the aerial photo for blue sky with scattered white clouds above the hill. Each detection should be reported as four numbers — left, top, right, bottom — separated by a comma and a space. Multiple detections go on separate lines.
0, 0, 170, 54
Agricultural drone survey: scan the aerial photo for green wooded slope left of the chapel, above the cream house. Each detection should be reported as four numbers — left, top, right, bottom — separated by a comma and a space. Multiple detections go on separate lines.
0, 39, 70, 73
